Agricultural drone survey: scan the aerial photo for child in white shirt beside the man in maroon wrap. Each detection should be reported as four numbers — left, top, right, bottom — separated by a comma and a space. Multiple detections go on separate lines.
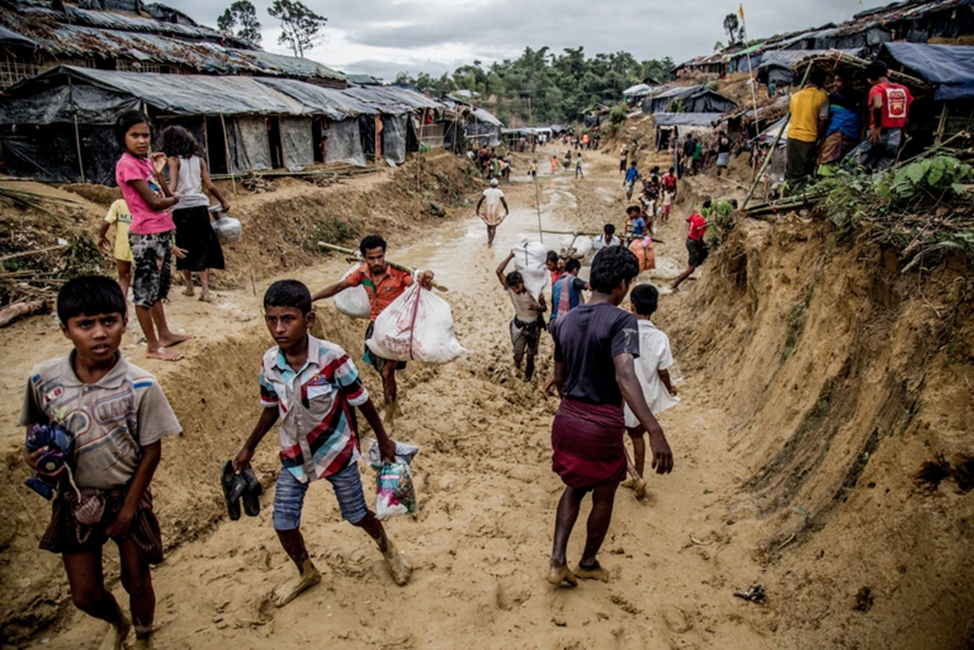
622, 284, 680, 498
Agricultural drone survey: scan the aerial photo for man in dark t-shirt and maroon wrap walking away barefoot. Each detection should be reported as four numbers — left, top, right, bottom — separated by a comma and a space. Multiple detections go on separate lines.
547, 246, 673, 586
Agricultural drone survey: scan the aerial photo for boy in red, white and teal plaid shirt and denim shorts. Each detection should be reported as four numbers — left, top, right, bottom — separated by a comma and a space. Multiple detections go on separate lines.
233, 280, 411, 607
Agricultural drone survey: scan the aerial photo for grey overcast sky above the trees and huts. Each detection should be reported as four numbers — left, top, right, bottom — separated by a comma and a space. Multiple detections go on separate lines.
162, 0, 888, 81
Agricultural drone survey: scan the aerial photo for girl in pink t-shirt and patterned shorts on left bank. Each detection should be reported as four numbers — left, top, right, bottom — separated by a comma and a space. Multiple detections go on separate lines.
115, 110, 193, 361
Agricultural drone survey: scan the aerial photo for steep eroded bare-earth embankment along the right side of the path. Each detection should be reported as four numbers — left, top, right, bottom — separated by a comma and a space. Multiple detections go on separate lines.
659, 196, 974, 648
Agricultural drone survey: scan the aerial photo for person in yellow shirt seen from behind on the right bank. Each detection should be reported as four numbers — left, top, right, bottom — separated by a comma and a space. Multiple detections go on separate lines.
785, 68, 829, 192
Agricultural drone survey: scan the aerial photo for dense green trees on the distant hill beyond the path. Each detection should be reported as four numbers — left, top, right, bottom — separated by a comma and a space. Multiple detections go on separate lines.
396, 46, 674, 124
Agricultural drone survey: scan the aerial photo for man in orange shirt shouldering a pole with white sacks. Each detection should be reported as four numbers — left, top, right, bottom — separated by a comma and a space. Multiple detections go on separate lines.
311, 235, 433, 408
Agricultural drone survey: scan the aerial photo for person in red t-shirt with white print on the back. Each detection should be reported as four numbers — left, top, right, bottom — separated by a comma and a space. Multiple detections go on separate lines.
849, 61, 913, 169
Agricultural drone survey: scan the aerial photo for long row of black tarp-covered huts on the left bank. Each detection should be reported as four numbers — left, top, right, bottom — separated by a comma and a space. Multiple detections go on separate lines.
0, 66, 454, 184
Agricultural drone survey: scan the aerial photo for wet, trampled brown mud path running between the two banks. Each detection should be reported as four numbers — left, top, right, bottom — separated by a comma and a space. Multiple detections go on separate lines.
15, 149, 776, 649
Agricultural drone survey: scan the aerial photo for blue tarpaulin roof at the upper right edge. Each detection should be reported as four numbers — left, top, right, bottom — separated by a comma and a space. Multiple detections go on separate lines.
883, 43, 974, 101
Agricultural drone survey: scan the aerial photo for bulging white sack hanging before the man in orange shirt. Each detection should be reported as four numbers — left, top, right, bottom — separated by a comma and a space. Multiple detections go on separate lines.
365, 282, 468, 363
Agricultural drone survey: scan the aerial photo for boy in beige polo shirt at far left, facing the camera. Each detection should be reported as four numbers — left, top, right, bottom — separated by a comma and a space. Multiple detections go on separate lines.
20, 277, 180, 650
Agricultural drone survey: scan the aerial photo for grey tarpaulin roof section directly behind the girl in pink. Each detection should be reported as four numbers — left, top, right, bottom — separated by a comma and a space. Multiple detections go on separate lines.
0, 65, 315, 123
